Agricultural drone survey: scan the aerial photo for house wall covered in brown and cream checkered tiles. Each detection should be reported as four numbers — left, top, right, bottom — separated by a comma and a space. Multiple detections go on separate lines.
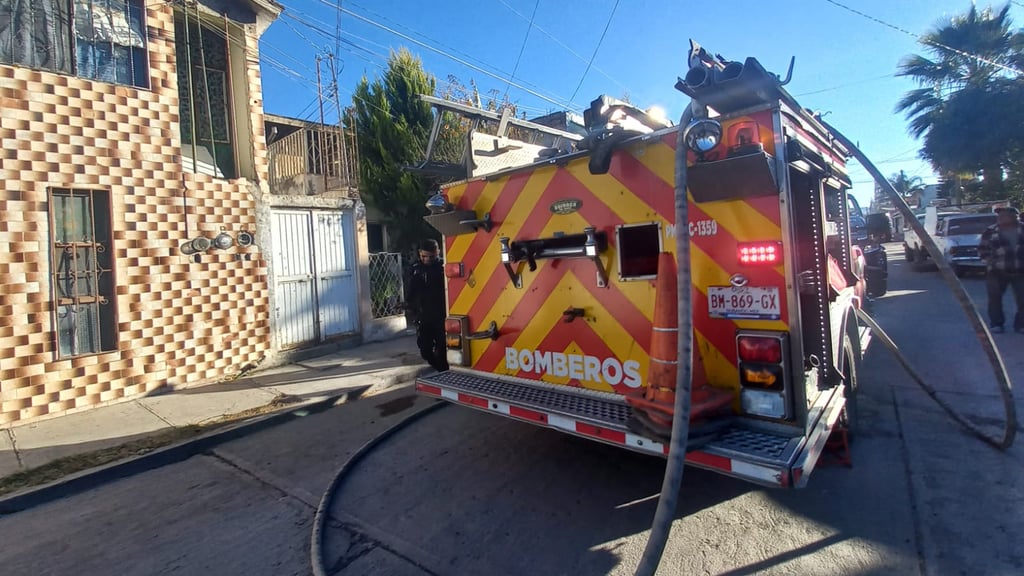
0, 3, 269, 423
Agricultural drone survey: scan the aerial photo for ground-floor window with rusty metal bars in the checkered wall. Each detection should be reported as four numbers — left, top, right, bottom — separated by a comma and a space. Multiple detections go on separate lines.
50, 189, 117, 358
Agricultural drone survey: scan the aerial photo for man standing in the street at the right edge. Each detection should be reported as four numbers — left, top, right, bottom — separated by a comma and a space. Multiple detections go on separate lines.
978, 204, 1024, 334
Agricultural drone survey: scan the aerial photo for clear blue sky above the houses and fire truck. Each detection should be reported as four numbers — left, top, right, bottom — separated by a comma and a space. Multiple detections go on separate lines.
260, 0, 1024, 205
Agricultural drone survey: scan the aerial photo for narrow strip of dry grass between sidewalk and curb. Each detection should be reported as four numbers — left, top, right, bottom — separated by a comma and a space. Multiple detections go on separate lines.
0, 395, 300, 496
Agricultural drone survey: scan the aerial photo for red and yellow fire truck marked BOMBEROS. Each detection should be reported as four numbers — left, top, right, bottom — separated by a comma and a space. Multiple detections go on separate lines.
413, 42, 870, 487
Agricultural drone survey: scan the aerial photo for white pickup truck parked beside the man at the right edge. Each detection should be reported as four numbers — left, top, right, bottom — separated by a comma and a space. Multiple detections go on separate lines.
903, 212, 995, 276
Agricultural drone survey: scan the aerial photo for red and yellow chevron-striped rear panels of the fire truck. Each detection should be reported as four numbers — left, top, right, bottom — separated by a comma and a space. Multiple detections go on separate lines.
445, 112, 787, 394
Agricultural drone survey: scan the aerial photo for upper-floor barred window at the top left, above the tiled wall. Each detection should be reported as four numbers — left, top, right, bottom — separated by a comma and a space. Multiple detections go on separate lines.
0, 0, 150, 88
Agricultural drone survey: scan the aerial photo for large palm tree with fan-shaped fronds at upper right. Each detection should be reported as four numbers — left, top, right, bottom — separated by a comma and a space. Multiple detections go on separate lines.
896, 4, 1024, 199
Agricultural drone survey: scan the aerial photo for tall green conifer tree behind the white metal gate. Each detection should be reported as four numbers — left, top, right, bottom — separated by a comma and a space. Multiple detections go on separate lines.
348, 48, 438, 253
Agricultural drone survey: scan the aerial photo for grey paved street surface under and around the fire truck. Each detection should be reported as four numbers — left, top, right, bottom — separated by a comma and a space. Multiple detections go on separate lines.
0, 242, 1024, 576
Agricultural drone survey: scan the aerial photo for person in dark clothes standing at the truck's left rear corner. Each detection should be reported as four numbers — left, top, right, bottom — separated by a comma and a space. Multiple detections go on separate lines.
409, 239, 449, 371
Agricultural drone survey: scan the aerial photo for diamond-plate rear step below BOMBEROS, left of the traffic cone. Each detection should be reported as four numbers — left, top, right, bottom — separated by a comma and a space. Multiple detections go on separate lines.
420, 371, 631, 427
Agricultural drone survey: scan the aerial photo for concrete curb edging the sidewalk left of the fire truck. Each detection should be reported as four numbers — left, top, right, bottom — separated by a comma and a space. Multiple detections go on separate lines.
0, 367, 431, 517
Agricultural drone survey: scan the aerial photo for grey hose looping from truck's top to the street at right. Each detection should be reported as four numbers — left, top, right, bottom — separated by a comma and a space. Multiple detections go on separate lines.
819, 119, 1017, 450
